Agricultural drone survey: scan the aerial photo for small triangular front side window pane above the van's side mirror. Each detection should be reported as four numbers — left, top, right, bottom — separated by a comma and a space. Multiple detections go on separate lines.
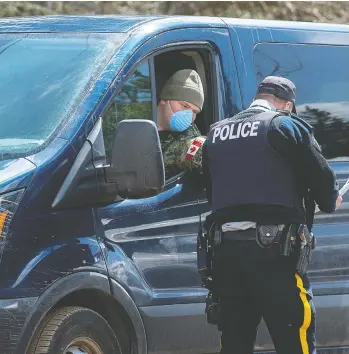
103, 61, 153, 162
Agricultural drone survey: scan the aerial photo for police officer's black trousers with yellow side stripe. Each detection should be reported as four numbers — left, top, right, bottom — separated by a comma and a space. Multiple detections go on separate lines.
213, 240, 316, 354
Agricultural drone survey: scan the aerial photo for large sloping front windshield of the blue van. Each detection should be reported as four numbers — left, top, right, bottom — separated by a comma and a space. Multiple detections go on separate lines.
0, 33, 125, 160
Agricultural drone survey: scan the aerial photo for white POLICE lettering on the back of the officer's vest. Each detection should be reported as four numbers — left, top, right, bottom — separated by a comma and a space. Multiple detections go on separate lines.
212, 120, 260, 143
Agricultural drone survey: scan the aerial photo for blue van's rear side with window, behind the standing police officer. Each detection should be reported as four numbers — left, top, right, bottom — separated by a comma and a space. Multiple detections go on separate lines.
227, 20, 349, 349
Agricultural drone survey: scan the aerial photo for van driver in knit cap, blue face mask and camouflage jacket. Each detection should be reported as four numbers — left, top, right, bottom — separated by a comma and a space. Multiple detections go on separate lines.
158, 69, 206, 179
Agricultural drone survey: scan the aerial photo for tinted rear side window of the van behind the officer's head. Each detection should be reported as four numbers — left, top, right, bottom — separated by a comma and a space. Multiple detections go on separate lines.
253, 43, 349, 161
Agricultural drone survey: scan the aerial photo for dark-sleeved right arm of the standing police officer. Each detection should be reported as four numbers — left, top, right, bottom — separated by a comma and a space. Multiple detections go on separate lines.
268, 116, 338, 213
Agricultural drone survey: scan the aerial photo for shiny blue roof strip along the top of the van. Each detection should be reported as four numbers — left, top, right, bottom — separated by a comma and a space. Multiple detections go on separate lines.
0, 15, 349, 33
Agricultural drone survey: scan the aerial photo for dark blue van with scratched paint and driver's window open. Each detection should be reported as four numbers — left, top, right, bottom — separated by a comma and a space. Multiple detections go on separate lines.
0, 16, 349, 354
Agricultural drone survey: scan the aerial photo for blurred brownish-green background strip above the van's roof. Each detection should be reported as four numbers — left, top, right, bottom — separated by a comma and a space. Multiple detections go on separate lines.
0, 1, 349, 23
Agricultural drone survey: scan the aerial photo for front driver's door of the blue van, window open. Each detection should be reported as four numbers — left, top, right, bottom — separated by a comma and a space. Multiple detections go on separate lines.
98, 28, 241, 353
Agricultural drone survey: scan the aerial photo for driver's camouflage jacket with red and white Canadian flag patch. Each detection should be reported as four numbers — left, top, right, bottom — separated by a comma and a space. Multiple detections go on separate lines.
159, 125, 206, 179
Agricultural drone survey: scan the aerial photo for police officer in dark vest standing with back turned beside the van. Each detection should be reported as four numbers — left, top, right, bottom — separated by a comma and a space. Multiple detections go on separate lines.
202, 76, 341, 354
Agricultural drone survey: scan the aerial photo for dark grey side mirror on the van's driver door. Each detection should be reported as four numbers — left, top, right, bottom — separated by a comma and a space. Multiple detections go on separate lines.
105, 119, 165, 198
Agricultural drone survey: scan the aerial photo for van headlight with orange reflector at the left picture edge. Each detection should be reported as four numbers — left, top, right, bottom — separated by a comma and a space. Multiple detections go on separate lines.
0, 189, 24, 242
